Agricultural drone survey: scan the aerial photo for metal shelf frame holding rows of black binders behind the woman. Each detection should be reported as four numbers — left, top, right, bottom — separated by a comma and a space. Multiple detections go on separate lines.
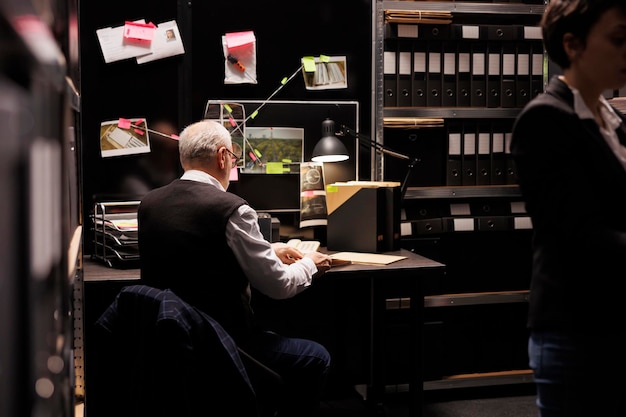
371, 1, 548, 391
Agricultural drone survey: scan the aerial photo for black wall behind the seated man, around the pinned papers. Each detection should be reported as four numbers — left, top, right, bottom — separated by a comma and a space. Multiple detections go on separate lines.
79, 0, 372, 254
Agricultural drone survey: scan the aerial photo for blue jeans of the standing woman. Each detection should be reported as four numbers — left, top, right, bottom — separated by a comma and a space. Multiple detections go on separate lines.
528, 330, 626, 417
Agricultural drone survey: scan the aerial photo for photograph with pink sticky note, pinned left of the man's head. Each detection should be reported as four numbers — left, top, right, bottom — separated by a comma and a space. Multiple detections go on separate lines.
100, 118, 150, 158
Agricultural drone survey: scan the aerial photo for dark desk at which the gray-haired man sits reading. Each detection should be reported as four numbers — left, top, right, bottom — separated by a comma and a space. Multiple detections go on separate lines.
84, 248, 445, 416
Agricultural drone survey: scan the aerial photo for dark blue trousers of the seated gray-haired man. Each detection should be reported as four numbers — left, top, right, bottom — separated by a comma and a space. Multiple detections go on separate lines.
247, 331, 330, 417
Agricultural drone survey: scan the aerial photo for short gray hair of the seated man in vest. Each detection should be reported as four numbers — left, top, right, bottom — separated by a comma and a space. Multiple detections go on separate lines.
178, 120, 232, 164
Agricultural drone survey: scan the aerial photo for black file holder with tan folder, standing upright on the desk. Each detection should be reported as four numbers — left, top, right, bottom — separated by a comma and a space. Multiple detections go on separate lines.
326, 181, 400, 252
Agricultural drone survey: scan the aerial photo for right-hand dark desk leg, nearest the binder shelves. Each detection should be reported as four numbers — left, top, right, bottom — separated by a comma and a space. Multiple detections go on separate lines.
409, 277, 424, 417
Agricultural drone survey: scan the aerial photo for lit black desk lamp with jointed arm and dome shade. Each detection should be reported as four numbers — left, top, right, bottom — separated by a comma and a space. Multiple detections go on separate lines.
311, 119, 420, 199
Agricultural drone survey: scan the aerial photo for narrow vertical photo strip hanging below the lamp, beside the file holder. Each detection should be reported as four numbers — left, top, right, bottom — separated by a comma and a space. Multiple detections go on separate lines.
300, 162, 327, 228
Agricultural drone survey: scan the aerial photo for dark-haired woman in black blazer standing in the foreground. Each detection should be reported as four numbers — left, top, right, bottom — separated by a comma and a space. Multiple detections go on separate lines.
511, 0, 626, 417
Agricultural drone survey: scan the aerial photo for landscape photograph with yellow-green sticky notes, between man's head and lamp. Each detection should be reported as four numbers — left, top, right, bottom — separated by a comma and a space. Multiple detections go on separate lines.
242, 127, 304, 174
